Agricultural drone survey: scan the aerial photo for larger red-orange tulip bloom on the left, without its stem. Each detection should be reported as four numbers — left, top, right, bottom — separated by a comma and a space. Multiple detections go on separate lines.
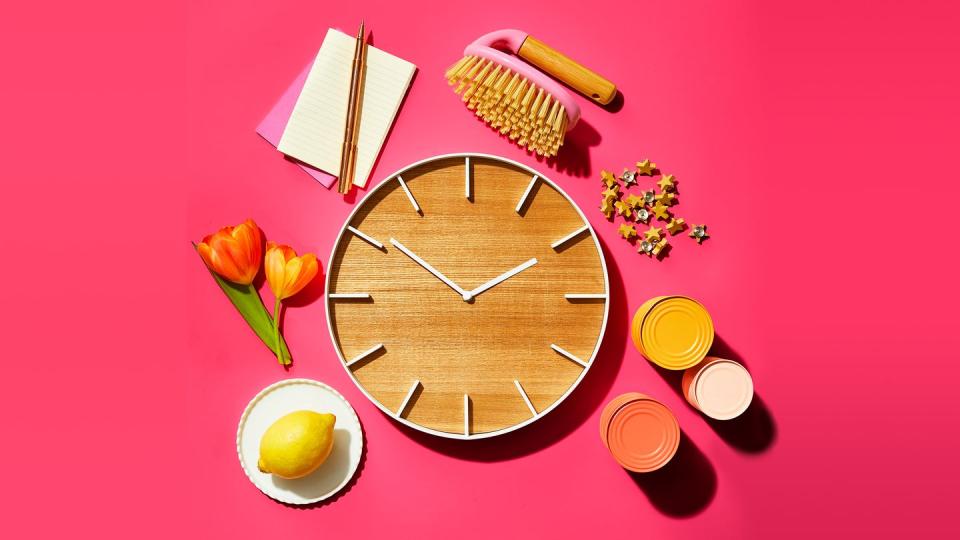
197, 219, 263, 285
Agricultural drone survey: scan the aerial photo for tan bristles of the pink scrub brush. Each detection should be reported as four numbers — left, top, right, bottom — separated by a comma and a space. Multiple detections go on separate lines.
446, 56, 567, 157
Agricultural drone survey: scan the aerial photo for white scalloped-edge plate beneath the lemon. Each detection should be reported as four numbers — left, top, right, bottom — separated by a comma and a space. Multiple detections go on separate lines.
237, 379, 363, 504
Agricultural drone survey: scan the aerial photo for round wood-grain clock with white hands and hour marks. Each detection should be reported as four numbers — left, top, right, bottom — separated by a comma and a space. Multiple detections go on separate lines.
326, 154, 609, 438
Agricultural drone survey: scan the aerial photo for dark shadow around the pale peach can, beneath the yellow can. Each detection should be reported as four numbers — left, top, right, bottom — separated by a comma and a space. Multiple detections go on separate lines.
650, 335, 777, 454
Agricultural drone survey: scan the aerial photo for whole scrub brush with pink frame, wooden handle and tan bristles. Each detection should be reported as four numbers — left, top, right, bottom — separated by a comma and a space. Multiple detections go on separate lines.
446, 30, 617, 157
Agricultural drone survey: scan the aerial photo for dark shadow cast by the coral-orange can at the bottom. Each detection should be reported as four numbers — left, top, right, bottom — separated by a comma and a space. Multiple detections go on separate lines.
625, 430, 717, 518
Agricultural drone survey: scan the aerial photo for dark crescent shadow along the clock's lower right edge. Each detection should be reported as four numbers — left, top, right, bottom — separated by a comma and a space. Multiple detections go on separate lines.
399, 240, 628, 462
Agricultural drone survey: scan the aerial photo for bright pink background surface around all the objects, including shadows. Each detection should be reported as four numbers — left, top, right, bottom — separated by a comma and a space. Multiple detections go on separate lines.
0, 0, 960, 539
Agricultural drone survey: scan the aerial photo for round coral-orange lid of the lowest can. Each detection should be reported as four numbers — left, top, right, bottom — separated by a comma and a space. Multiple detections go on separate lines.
607, 398, 680, 472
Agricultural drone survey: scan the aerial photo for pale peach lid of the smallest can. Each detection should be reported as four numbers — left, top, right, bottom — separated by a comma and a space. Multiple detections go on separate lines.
693, 358, 753, 420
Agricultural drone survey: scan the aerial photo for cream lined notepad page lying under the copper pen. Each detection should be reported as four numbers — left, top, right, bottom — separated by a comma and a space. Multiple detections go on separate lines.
277, 28, 417, 187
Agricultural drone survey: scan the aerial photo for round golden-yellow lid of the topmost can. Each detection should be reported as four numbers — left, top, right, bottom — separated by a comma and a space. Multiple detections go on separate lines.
640, 296, 713, 370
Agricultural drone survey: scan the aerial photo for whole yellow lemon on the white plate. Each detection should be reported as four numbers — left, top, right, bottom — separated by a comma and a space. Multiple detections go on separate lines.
257, 411, 337, 478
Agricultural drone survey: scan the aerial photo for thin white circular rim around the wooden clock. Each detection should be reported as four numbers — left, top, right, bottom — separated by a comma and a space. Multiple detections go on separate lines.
323, 152, 611, 440
